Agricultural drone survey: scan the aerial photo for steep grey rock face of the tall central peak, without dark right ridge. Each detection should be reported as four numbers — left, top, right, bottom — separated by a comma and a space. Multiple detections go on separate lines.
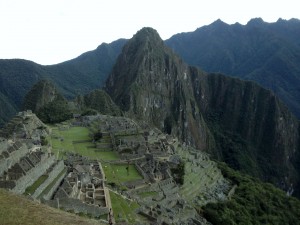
106, 28, 214, 149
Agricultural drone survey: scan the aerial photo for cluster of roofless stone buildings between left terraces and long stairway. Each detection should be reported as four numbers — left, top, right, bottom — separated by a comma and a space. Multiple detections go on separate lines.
43, 153, 111, 217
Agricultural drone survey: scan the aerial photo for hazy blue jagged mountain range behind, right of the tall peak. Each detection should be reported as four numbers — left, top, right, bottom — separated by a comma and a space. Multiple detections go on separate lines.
165, 18, 300, 118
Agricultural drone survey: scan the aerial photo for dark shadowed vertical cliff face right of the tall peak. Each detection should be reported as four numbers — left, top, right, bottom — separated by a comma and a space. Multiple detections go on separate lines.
193, 74, 299, 185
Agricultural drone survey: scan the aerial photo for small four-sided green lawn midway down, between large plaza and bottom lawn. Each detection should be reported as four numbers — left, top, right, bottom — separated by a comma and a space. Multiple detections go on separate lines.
102, 163, 143, 185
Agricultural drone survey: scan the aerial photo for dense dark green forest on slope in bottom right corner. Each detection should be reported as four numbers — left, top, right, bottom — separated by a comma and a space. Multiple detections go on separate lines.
203, 163, 300, 225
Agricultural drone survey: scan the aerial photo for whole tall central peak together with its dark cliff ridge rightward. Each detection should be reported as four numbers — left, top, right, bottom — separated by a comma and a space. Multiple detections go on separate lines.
106, 28, 300, 196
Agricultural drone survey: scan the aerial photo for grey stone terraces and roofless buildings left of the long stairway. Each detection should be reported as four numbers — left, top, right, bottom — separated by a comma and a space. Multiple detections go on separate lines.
0, 111, 111, 221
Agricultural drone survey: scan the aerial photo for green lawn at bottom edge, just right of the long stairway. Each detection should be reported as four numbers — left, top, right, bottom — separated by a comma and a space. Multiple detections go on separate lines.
109, 191, 139, 224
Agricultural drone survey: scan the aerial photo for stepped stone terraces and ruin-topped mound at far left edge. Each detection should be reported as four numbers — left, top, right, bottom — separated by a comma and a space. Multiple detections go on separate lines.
0, 111, 64, 199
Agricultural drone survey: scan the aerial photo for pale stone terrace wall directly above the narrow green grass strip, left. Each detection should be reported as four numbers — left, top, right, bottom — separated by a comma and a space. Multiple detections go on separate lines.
12, 155, 55, 194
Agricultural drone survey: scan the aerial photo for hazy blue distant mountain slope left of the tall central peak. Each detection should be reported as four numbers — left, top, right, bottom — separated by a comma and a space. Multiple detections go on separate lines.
0, 39, 126, 125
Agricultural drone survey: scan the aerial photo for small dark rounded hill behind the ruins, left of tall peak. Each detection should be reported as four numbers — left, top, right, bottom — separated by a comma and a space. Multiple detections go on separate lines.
23, 80, 72, 123
